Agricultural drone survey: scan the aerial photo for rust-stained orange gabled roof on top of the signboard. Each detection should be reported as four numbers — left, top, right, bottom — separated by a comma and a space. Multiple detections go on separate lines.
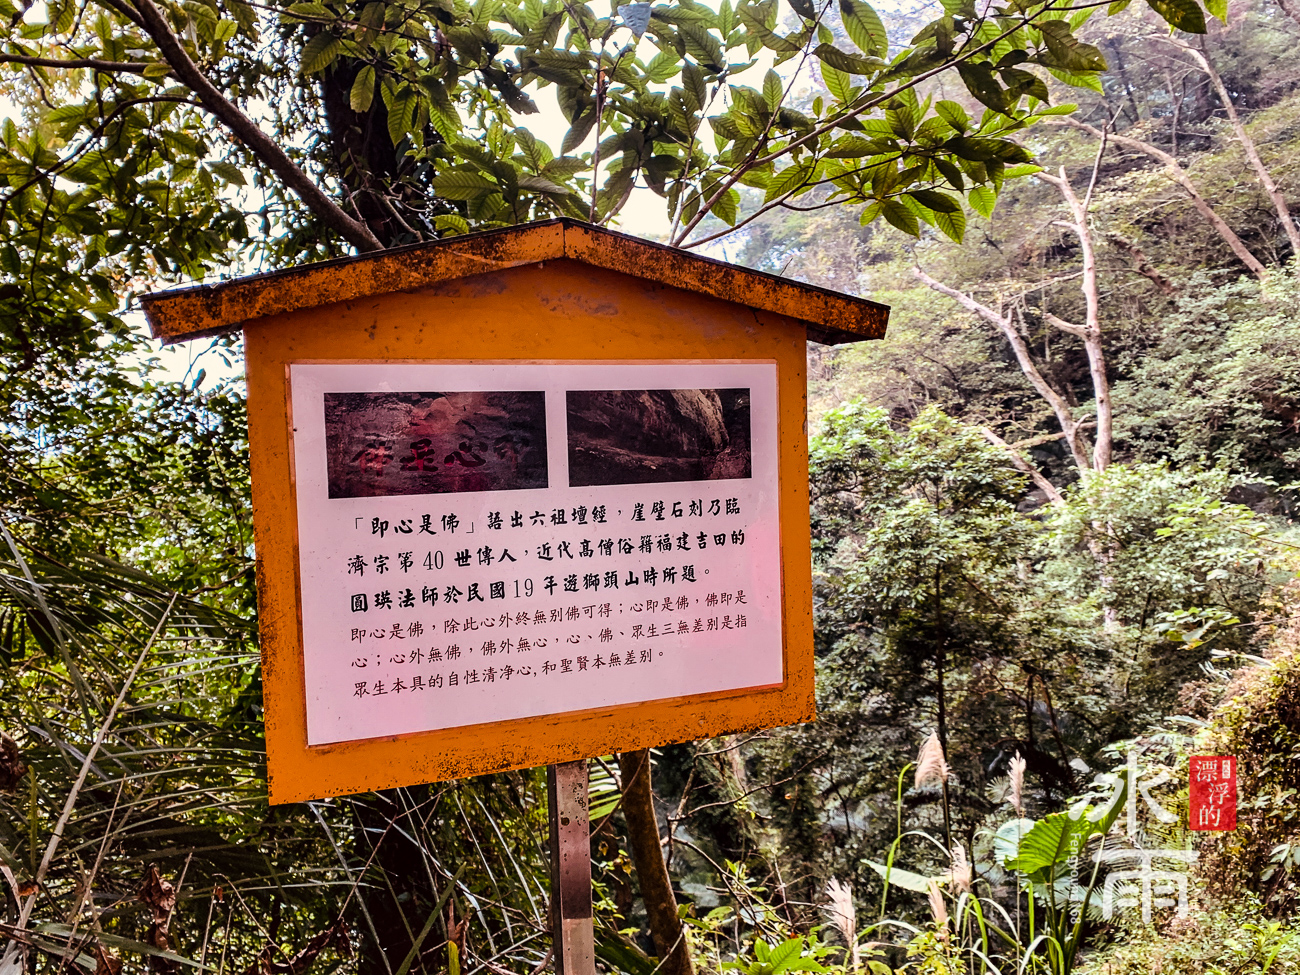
142, 217, 889, 345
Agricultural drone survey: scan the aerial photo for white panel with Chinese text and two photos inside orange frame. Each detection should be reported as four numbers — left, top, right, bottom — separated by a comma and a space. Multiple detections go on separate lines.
290, 363, 783, 745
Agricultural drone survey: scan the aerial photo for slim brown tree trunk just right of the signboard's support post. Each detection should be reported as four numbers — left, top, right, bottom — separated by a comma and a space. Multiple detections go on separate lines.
619, 749, 694, 975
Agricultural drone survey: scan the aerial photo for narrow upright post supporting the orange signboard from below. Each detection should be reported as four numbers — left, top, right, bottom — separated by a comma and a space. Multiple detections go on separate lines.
546, 761, 595, 975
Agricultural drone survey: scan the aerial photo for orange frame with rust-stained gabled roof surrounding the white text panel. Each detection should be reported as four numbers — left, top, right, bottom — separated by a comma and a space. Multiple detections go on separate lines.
146, 221, 888, 803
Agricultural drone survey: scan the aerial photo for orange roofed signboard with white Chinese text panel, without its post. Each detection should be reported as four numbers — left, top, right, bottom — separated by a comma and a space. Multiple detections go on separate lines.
144, 220, 888, 802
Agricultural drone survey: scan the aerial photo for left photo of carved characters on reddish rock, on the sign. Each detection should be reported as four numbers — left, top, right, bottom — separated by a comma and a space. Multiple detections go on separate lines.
325, 390, 546, 498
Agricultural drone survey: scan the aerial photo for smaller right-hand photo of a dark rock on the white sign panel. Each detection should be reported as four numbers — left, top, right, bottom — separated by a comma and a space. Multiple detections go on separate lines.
567, 389, 753, 488
